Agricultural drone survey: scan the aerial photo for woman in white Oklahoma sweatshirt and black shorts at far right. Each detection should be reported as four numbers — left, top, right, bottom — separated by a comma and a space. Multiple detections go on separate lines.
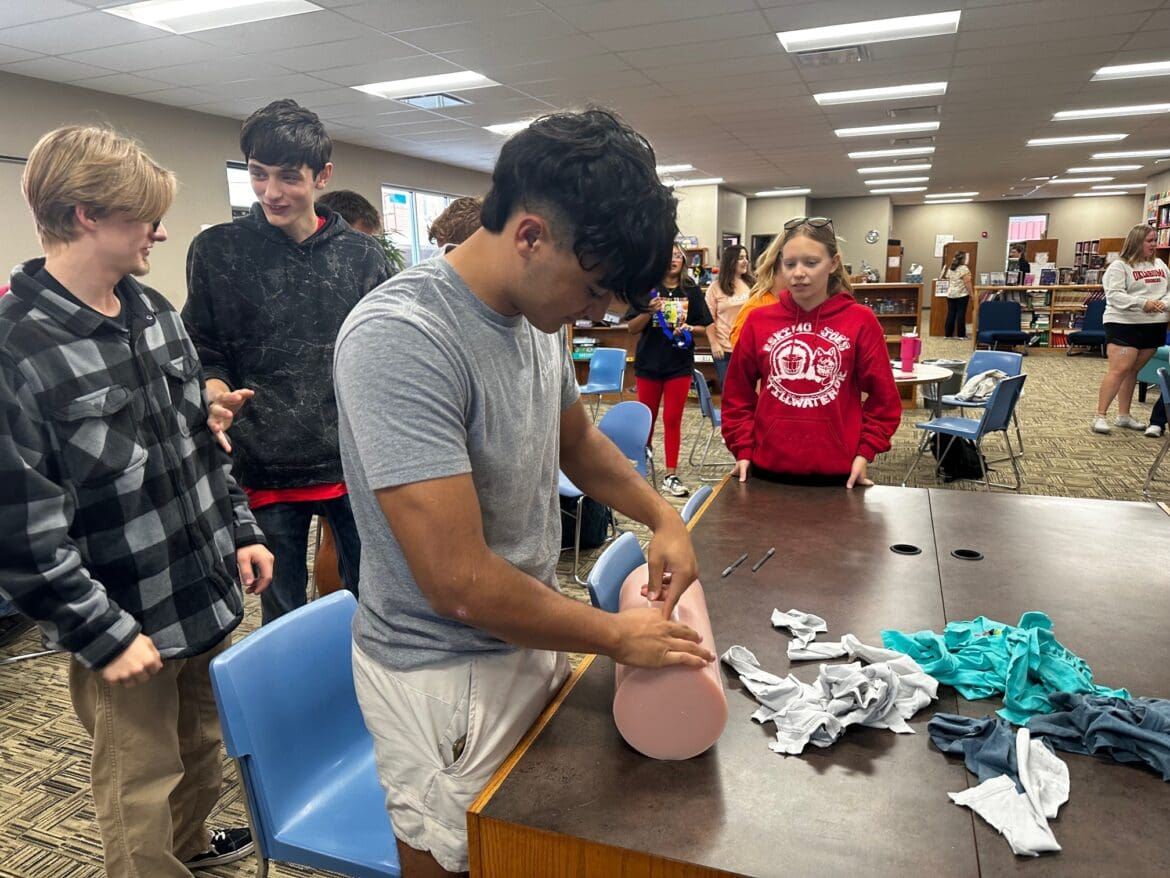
1093, 222, 1170, 433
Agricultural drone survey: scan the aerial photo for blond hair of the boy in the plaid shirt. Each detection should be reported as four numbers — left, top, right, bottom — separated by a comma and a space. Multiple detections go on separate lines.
21, 125, 176, 248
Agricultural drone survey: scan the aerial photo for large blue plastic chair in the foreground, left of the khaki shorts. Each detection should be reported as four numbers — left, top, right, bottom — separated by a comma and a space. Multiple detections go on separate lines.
211, 590, 401, 878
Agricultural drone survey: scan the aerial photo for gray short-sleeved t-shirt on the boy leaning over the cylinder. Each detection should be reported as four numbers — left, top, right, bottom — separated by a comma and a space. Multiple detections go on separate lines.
333, 256, 579, 670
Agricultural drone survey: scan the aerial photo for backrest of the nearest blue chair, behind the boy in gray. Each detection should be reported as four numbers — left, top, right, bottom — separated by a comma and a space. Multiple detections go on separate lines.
211, 590, 373, 851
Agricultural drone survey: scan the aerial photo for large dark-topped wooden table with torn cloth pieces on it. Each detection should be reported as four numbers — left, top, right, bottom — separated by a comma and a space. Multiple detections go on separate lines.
469, 480, 1170, 878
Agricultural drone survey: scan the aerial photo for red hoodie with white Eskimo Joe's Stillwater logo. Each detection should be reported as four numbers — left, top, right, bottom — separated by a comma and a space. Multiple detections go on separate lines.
722, 290, 902, 475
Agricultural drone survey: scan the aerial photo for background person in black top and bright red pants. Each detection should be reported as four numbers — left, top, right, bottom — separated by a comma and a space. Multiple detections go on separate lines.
626, 245, 714, 496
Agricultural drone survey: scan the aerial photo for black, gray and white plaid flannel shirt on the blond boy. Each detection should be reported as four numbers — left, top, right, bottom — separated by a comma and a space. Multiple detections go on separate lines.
0, 260, 264, 668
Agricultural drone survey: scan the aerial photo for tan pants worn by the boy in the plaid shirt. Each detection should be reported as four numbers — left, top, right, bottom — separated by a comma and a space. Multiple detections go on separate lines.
69, 637, 232, 878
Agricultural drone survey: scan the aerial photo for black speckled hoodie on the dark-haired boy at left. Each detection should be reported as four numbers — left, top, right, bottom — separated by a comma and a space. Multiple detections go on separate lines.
183, 204, 391, 489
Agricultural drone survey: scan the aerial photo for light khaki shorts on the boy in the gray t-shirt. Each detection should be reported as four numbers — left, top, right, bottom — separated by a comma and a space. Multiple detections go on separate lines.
353, 644, 569, 872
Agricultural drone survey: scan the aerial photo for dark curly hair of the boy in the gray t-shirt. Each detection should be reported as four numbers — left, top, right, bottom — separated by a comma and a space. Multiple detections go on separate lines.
482, 108, 677, 310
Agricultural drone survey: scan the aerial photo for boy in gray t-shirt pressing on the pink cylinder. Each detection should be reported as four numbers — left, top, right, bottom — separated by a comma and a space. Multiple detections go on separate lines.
335, 110, 715, 874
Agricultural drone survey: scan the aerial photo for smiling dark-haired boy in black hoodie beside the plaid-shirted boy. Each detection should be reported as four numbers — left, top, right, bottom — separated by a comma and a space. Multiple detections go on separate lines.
183, 98, 391, 623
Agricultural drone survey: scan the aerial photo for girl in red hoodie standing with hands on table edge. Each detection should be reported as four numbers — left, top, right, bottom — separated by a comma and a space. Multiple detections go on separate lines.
723, 217, 902, 488
